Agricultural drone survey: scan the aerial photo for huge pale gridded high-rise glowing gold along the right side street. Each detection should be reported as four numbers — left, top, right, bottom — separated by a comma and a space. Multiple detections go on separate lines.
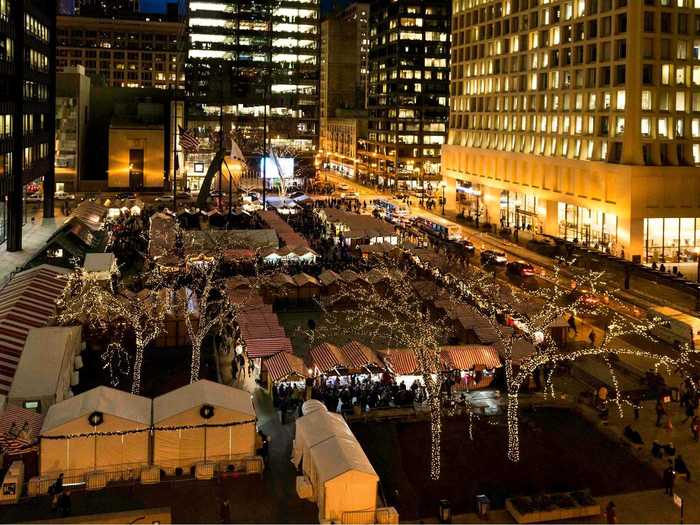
443, 0, 700, 262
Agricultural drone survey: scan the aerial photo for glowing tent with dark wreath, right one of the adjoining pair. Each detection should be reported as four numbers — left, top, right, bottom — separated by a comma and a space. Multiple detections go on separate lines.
153, 380, 256, 471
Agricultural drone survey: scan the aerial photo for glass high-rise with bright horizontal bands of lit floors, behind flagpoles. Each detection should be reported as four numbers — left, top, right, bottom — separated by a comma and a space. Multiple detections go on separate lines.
181, 0, 320, 189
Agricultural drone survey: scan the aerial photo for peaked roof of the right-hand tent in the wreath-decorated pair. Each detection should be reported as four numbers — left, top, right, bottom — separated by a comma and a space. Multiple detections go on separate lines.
153, 379, 255, 424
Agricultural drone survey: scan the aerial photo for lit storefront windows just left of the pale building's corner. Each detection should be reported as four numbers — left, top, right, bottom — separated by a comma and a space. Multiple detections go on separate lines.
558, 202, 618, 251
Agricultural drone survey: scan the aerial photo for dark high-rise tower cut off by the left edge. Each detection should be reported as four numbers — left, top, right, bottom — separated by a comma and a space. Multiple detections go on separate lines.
0, 0, 56, 251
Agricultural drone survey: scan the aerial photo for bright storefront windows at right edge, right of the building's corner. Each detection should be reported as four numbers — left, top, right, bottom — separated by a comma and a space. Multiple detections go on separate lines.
644, 217, 700, 263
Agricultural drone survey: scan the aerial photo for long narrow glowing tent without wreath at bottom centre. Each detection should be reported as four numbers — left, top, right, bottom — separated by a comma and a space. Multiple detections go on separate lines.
294, 410, 379, 523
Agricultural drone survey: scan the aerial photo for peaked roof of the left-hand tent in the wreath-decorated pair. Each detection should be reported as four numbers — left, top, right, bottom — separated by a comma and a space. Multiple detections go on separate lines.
41, 386, 151, 434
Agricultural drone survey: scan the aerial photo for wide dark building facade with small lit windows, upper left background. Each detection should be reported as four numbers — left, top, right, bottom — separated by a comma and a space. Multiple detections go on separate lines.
57, 16, 185, 90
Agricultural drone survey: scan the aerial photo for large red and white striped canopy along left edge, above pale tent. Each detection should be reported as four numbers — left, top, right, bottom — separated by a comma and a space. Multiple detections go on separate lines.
0, 265, 68, 395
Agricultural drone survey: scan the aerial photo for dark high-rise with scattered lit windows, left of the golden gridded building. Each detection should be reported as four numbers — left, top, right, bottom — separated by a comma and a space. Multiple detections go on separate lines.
360, 0, 451, 188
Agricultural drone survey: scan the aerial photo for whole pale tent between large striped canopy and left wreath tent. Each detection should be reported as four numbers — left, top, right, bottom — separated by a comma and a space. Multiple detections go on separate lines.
8, 326, 81, 414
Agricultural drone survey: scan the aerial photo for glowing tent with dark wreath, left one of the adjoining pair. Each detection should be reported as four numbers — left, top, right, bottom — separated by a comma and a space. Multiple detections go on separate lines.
40, 386, 151, 476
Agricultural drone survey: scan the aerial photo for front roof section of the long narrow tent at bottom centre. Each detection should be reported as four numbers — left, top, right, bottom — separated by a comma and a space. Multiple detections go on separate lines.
306, 432, 379, 483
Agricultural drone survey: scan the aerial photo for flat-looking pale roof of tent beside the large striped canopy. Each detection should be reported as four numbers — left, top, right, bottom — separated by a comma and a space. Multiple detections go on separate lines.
9, 326, 81, 398
